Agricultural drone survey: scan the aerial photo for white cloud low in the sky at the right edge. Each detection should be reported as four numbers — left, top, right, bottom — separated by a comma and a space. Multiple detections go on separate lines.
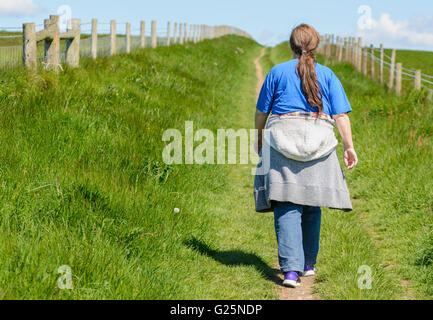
358, 13, 433, 51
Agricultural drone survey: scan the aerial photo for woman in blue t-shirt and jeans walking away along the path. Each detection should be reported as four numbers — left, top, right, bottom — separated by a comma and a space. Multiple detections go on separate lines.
254, 24, 358, 288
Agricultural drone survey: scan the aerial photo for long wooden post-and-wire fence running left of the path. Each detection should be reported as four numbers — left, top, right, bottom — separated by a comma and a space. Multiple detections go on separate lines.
0, 15, 251, 70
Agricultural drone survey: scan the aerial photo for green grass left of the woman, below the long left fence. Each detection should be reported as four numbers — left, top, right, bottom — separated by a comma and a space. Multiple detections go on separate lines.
0, 36, 277, 299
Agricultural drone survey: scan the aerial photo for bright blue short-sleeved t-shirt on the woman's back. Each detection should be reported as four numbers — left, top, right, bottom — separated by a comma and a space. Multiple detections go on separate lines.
257, 59, 352, 116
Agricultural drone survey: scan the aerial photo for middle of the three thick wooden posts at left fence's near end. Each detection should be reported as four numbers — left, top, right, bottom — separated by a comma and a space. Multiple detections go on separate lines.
44, 15, 60, 71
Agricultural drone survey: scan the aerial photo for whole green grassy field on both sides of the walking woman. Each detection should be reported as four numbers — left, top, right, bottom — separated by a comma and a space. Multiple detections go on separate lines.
0, 36, 433, 299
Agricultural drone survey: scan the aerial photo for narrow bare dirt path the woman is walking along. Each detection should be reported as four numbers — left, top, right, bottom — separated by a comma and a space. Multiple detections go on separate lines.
254, 48, 319, 300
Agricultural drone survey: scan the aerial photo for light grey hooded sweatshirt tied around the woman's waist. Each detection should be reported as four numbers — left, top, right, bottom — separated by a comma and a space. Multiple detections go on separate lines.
254, 112, 352, 212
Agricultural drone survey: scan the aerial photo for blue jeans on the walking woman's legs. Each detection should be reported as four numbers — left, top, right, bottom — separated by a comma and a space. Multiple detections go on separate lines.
274, 202, 322, 272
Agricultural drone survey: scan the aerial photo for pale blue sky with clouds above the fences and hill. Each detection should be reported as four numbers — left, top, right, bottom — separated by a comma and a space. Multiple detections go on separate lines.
0, 0, 433, 51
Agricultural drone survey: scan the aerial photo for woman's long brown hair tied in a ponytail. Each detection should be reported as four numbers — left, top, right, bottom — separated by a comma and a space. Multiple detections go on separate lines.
290, 24, 323, 112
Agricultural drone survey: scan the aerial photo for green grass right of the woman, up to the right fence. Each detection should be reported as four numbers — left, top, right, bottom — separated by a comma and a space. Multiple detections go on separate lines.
264, 44, 433, 299
